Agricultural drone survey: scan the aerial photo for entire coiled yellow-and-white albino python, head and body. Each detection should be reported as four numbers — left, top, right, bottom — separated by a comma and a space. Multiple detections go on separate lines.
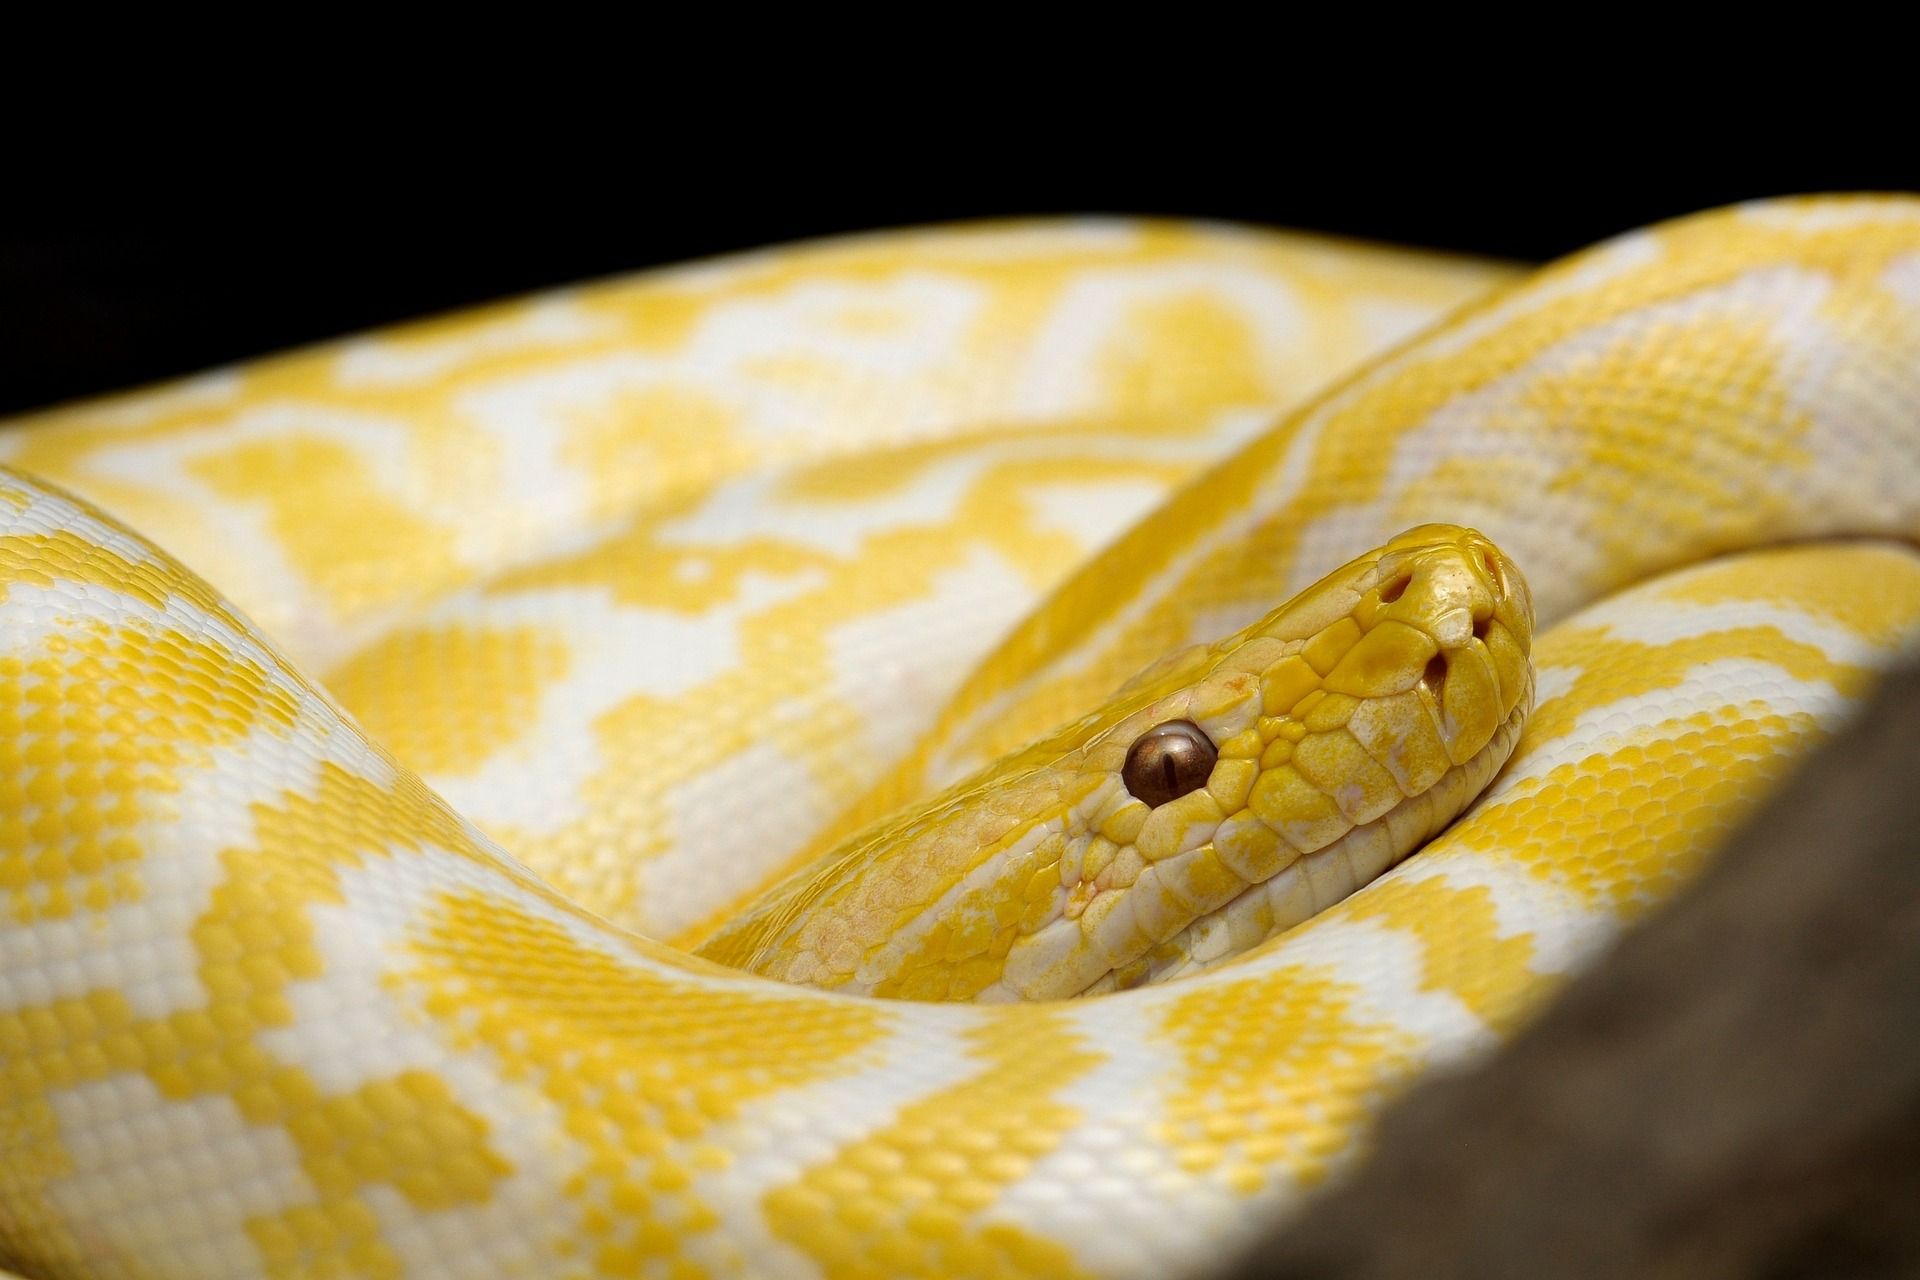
0, 198, 1920, 1280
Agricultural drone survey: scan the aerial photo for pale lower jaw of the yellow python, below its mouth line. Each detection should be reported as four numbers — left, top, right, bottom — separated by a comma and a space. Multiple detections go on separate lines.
1079, 668, 1534, 996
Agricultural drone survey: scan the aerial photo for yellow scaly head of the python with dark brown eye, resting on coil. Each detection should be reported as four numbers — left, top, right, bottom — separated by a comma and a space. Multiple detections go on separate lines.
703, 524, 1534, 1000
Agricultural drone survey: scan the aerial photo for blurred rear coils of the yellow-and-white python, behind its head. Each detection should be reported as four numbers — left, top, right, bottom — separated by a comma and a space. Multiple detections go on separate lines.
0, 221, 1511, 940
